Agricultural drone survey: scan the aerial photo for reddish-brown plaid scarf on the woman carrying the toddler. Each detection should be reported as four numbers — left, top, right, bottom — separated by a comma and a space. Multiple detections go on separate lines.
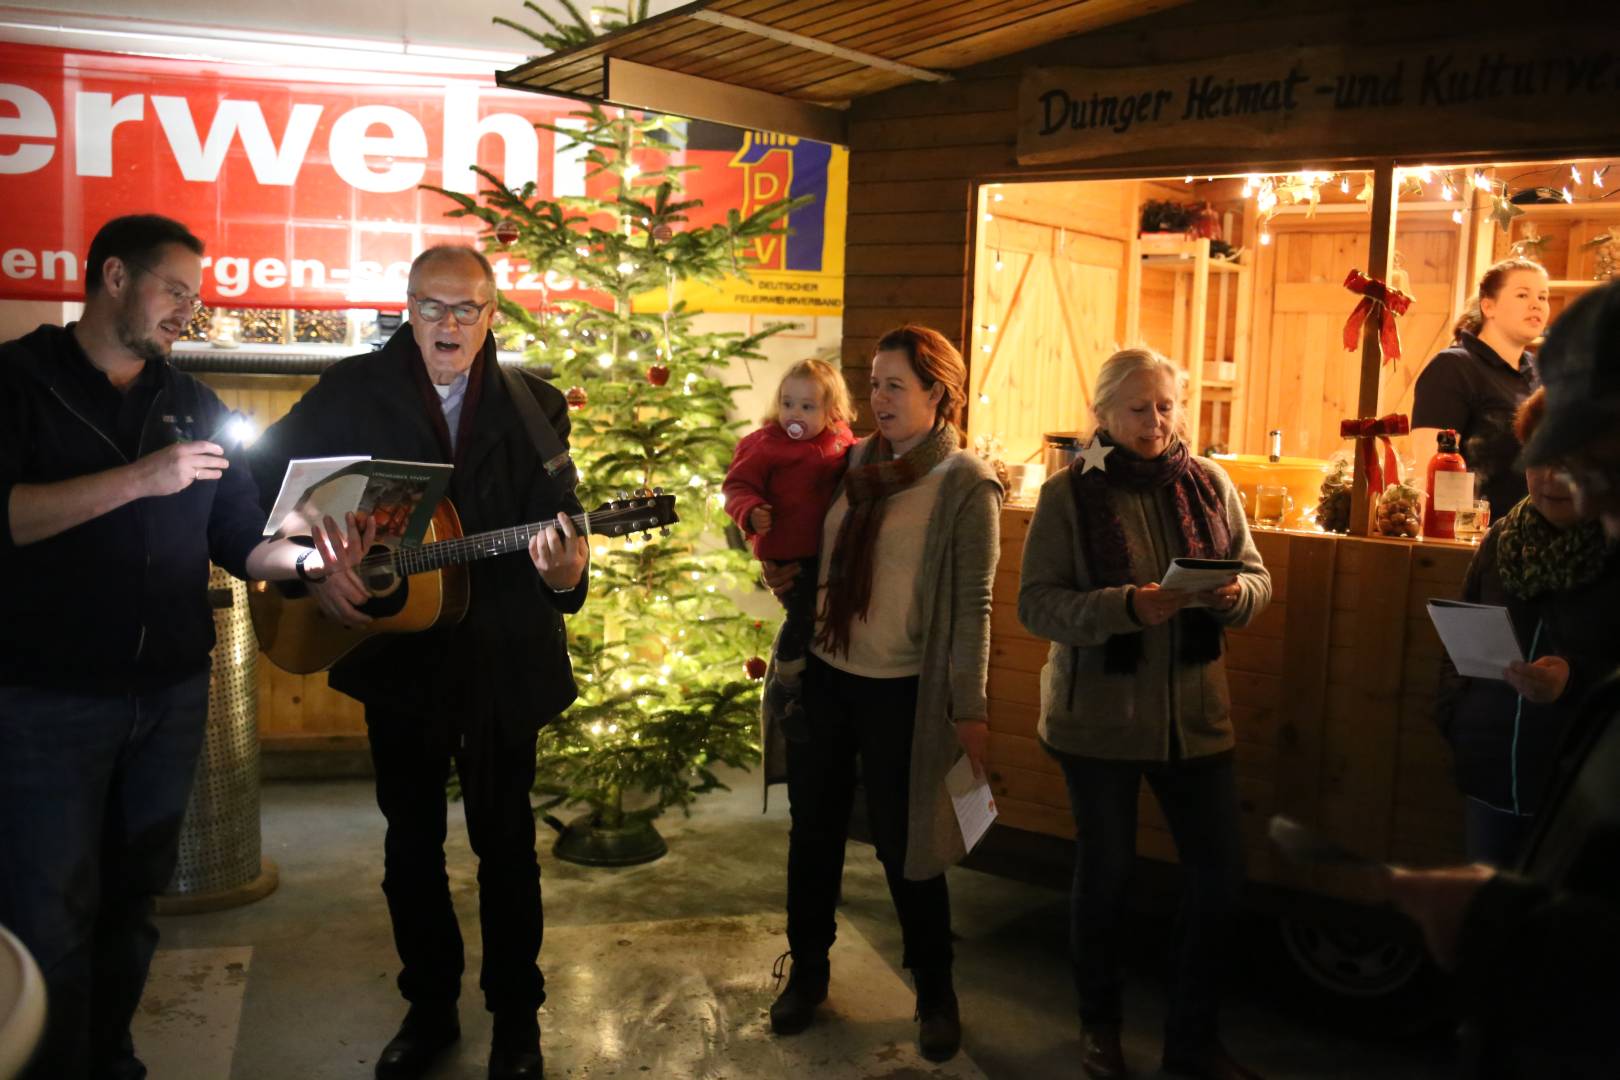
816, 424, 957, 656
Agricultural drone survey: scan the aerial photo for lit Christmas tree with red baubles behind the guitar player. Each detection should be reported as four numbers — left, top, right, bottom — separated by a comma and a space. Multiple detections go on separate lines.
427, 107, 804, 863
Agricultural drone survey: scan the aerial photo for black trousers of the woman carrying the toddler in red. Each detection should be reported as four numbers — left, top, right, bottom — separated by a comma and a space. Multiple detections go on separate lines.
787, 654, 951, 970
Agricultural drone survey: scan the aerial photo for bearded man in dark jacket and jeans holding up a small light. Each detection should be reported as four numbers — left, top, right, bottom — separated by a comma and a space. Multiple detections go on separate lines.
0, 215, 361, 1080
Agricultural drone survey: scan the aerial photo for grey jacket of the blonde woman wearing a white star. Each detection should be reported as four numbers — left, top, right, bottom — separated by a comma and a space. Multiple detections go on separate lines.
1017, 458, 1272, 761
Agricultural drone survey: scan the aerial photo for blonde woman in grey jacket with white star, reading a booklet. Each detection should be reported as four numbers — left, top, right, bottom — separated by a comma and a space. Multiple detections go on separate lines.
1017, 348, 1272, 1078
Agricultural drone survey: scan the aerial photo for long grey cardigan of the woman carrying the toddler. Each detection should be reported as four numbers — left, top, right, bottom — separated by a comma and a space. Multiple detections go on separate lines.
760, 436, 1001, 881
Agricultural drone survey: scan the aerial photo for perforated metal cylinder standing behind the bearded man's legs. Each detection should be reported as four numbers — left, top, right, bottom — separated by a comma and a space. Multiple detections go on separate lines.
157, 567, 277, 915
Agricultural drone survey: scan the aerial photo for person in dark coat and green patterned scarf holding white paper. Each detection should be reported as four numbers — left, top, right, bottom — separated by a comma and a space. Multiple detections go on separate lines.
1435, 390, 1620, 868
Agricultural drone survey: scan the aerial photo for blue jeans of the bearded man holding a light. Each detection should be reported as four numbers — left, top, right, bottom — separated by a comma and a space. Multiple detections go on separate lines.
0, 672, 207, 1080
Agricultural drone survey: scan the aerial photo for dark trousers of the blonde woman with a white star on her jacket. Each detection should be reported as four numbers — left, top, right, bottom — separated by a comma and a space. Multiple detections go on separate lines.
1048, 748, 1243, 1056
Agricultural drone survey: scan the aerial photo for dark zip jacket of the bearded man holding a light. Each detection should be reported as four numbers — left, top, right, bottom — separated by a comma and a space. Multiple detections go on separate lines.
0, 325, 264, 695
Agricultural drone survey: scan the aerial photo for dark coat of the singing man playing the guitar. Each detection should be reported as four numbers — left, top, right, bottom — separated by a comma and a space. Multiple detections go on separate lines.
253, 324, 586, 740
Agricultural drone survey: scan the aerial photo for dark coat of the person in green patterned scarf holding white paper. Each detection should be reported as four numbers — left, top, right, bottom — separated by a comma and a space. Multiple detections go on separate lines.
1435, 521, 1620, 814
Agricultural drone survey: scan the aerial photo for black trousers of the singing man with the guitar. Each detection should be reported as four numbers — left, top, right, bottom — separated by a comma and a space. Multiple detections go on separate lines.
366, 706, 546, 1014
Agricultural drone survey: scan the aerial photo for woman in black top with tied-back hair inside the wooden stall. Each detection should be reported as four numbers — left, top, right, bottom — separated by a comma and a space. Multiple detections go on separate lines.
1411, 259, 1547, 518
